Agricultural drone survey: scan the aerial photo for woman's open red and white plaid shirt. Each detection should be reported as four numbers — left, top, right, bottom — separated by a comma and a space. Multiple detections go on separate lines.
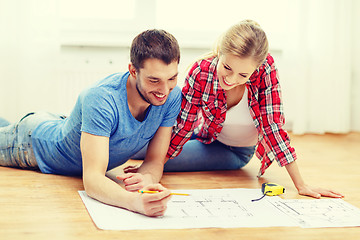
167, 54, 296, 176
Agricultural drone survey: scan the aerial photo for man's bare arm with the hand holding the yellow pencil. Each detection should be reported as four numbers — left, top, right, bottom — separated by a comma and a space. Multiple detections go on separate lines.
80, 132, 170, 216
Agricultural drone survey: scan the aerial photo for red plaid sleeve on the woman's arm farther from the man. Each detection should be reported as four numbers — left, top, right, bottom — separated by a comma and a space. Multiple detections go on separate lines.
257, 55, 296, 176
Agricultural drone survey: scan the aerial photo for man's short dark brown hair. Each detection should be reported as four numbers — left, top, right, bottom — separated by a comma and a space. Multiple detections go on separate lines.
130, 29, 180, 70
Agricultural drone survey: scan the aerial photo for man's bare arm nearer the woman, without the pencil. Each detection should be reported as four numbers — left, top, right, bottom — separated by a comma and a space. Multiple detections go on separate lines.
118, 127, 172, 191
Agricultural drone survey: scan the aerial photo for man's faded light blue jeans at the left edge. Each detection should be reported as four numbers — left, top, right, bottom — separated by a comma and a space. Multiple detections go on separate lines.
0, 113, 60, 170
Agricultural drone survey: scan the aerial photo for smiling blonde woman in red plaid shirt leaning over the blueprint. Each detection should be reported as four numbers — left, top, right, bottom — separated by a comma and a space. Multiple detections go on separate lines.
132, 20, 343, 198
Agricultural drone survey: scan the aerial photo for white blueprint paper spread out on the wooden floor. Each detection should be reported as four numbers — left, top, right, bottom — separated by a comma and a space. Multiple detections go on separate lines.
79, 188, 360, 230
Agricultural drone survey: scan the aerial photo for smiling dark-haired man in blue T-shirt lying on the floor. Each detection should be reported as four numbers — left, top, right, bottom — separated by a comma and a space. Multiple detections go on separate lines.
0, 30, 181, 216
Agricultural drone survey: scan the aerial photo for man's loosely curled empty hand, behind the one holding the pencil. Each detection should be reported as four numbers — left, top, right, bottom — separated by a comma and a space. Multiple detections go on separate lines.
116, 173, 153, 192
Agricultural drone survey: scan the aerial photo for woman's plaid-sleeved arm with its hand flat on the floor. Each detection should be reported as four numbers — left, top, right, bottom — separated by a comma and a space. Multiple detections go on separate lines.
259, 55, 343, 198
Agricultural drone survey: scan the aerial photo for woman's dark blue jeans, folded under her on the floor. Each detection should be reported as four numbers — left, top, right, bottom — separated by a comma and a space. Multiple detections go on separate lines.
131, 138, 255, 172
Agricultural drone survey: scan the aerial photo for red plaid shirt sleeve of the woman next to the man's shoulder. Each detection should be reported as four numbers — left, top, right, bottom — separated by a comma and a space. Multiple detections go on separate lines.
166, 63, 202, 159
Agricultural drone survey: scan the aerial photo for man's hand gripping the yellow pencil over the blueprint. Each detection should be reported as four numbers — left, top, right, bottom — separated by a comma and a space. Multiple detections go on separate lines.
134, 184, 171, 217
